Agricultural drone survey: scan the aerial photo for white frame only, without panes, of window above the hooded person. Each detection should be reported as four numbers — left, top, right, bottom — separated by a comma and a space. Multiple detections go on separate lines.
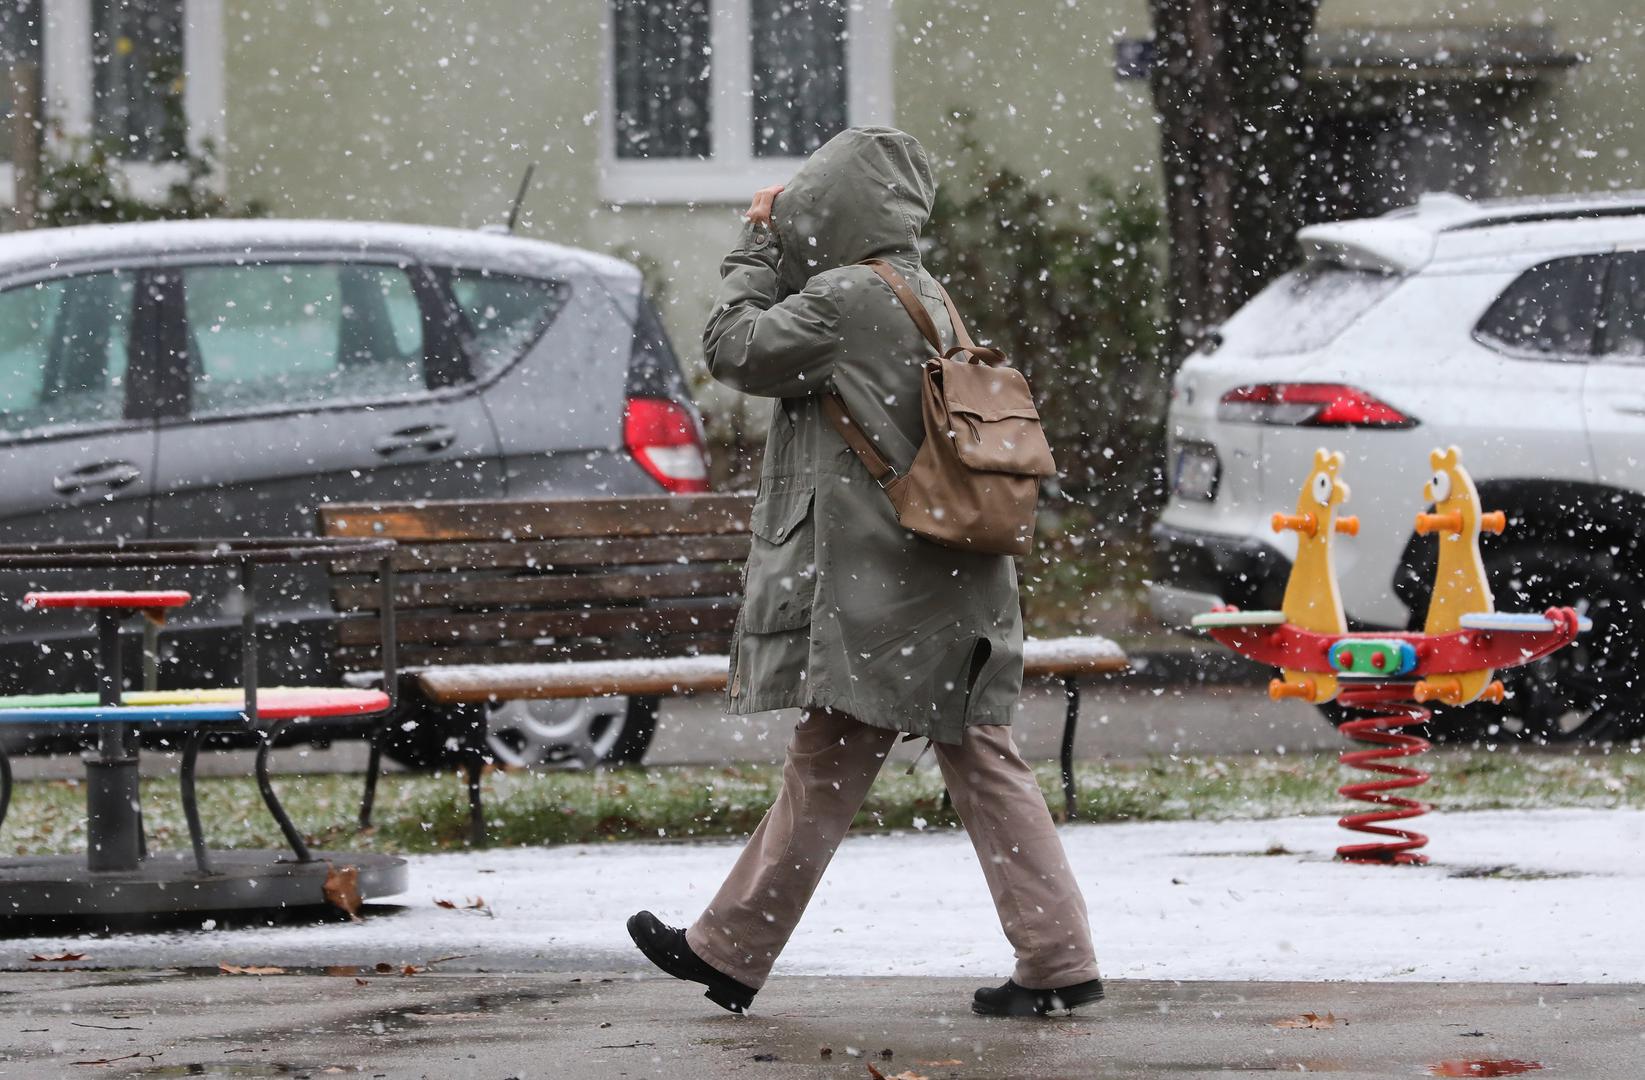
599, 0, 897, 205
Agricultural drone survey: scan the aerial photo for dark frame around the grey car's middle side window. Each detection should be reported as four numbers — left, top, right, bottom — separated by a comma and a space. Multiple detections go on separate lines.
150, 252, 477, 427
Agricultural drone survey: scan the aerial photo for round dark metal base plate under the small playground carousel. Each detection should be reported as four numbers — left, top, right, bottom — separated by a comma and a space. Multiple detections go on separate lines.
0, 852, 406, 927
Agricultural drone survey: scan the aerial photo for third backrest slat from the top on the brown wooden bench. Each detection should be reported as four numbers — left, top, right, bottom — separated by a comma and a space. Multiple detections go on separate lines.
332, 567, 742, 612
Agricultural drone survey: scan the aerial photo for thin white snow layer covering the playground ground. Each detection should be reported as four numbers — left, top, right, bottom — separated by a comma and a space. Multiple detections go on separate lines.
0, 810, 1645, 981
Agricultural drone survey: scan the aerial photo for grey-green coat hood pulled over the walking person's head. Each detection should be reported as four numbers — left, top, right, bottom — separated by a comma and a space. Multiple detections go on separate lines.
772, 128, 936, 293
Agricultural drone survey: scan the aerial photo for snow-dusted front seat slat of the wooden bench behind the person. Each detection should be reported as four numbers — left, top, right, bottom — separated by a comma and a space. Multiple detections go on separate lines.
416, 638, 1128, 704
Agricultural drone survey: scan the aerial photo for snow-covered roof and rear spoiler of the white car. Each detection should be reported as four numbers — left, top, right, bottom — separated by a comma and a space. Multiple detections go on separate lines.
1298, 191, 1645, 273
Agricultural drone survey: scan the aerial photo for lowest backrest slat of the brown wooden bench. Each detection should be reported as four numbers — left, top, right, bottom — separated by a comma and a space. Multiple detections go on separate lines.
337, 600, 737, 646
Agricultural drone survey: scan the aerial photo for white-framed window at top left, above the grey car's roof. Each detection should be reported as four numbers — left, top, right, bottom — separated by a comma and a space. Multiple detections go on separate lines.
0, 0, 224, 202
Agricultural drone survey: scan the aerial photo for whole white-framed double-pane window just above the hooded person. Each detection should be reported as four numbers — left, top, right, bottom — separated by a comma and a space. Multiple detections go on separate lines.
600, 0, 892, 202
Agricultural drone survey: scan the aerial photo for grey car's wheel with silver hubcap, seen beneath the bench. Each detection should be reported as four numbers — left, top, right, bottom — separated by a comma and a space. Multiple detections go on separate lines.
487, 697, 658, 769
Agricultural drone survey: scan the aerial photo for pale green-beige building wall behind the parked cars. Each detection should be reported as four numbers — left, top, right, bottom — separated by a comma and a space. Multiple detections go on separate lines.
225, 0, 1645, 417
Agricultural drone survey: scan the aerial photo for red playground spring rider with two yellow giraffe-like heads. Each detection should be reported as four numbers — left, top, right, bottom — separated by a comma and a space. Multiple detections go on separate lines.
1194, 447, 1591, 863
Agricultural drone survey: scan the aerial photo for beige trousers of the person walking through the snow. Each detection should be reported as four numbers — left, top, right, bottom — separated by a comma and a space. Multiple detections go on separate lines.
686, 708, 1097, 990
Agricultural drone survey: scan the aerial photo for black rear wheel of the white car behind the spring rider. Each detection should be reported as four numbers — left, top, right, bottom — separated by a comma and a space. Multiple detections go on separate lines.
1476, 544, 1645, 743
